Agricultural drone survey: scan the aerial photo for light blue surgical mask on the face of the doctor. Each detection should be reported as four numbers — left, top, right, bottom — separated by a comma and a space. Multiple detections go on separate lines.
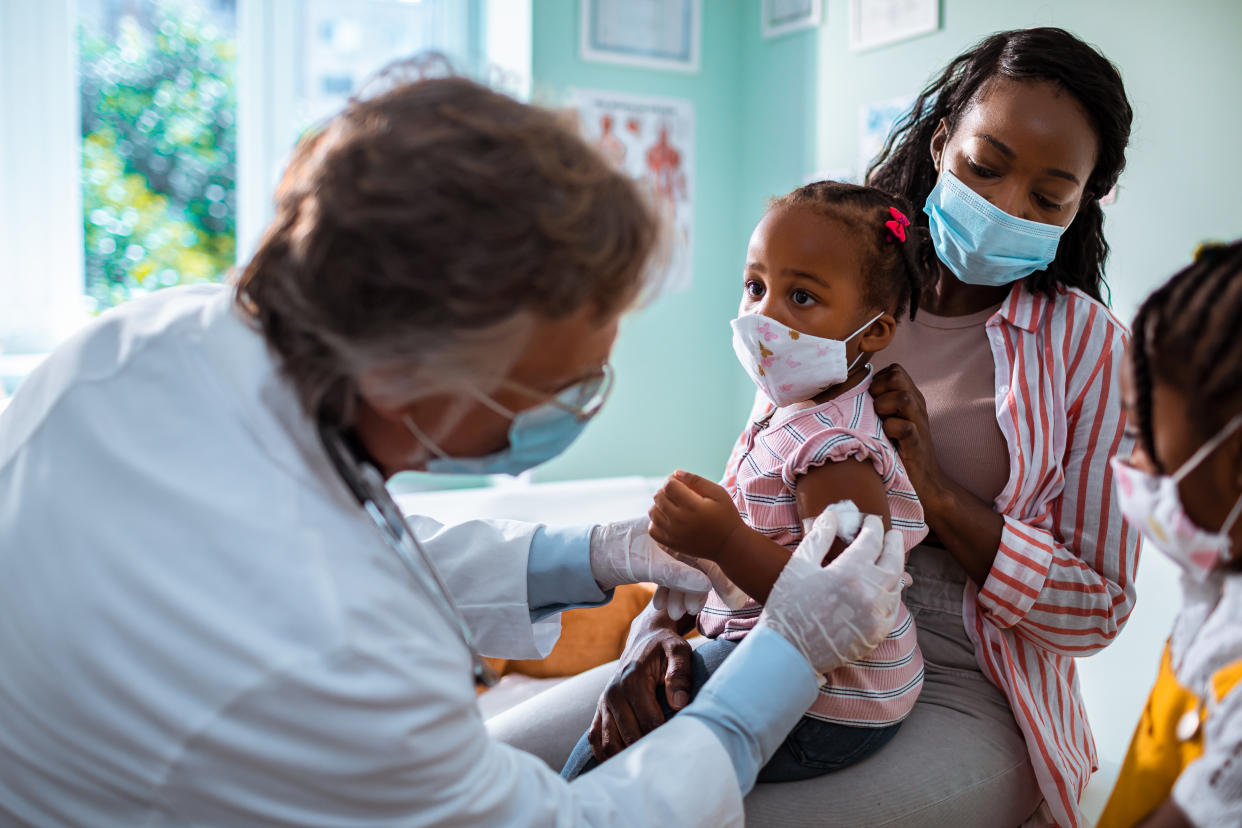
405, 365, 612, 474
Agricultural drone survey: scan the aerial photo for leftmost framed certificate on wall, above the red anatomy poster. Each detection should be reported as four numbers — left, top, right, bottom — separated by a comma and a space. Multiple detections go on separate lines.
579, 0, 703, 72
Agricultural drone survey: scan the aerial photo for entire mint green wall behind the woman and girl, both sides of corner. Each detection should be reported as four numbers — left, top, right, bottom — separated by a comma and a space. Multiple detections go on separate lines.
533, 0, 1242, 479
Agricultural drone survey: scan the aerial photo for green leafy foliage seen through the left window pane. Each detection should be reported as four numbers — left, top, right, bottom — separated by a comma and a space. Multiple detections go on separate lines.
79, 0, 237, 310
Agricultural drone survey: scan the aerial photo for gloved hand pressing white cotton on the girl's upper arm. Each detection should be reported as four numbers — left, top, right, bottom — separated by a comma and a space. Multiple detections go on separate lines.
759, 510, 905, 675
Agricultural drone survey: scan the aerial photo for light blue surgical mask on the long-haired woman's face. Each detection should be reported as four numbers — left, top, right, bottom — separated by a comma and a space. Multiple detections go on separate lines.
923, 170, 1066, 287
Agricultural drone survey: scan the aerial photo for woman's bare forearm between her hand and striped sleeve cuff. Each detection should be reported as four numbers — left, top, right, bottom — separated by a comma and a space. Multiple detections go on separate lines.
919, 478, 1005, 586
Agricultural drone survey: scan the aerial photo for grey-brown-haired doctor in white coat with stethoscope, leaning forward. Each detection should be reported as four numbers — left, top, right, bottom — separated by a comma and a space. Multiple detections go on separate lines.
0, 78, 900, 826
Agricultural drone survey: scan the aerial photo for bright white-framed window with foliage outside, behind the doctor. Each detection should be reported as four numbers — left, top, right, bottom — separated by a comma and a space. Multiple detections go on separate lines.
0, 0, 530, 398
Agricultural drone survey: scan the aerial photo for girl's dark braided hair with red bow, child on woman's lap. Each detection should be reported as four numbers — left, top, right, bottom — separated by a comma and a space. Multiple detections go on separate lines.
769, 181, 935, 319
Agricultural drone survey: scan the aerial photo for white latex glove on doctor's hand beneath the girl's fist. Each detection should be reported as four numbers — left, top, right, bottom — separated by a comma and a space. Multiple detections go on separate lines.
591, 515, 712, 593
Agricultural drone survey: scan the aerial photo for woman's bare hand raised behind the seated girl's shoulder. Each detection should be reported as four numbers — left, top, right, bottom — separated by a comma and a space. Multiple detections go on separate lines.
871, 364, 946, 511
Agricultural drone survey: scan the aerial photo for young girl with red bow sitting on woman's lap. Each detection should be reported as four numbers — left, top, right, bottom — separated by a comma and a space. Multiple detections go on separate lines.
564, 181, 932, 782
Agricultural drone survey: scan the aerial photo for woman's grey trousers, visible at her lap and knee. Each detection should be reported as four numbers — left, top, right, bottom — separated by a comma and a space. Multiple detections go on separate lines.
487, 614, 1041, 828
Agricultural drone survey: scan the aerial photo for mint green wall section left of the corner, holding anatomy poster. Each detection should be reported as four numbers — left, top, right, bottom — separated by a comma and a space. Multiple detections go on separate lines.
533, 0, 759, 480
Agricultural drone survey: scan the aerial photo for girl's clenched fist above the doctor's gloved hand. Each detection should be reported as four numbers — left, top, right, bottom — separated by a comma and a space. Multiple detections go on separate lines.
648, 470, 745, 561
